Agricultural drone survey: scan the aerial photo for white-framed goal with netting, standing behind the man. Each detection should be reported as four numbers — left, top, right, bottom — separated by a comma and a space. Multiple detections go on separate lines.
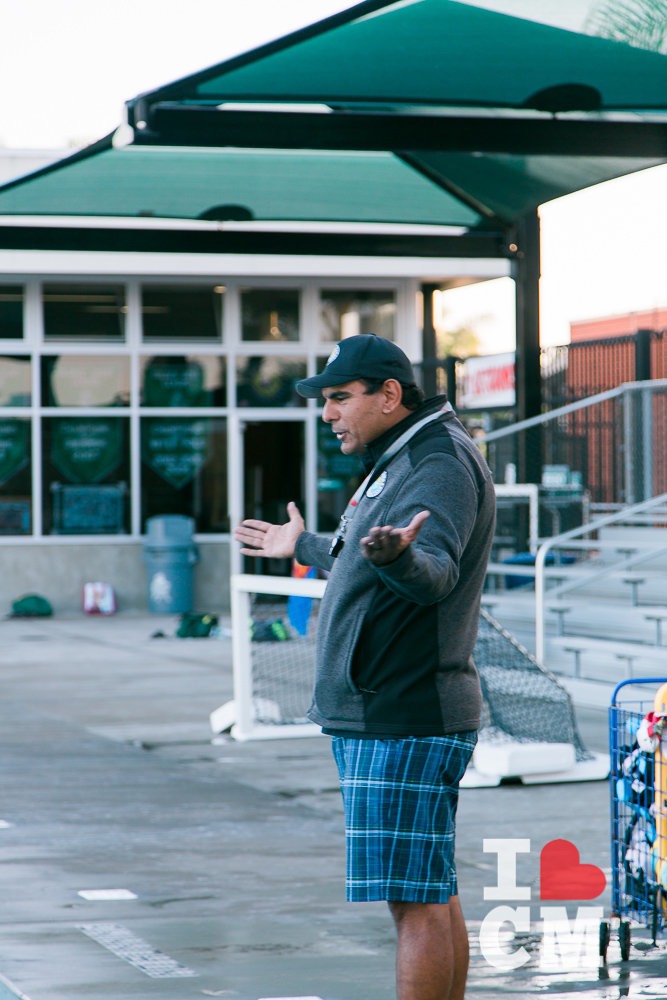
211, 574, 596, 776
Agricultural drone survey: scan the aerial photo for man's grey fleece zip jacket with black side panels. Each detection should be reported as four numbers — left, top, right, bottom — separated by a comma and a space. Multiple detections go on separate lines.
295, 397, 496, 738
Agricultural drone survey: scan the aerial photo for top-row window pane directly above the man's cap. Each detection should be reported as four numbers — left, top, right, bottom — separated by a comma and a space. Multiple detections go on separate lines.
320, 289, 396, 341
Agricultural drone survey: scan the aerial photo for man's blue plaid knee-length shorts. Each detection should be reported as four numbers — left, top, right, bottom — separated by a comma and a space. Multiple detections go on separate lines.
332, 731, 477, 903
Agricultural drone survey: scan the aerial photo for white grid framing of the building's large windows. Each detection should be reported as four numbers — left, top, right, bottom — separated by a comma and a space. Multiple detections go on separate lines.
0, 276, 412, 540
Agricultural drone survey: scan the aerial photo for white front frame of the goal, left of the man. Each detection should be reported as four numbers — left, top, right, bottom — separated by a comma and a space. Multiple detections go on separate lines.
211, 573, 326, 740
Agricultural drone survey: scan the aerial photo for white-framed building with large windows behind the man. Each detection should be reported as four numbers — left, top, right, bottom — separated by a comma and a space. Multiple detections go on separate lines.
0, 154, 509, 610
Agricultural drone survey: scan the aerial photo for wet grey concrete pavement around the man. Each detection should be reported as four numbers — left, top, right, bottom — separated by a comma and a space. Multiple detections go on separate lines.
0, 613, 667, 1000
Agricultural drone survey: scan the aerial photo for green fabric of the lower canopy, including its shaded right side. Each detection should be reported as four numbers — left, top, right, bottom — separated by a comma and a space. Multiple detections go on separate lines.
0, 139, 657, 230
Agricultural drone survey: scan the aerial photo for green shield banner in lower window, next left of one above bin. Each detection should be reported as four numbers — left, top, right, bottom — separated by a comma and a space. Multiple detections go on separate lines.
51, 417, 123, 483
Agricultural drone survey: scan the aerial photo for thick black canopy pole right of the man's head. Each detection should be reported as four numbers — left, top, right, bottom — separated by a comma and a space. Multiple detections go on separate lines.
514, 209, 542, 483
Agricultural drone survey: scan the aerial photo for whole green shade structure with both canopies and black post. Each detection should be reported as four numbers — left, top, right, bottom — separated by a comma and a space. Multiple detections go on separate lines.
0, 0, 667, 426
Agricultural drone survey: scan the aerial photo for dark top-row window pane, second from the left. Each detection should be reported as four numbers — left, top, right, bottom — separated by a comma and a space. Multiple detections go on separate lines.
42, 285, 126, 341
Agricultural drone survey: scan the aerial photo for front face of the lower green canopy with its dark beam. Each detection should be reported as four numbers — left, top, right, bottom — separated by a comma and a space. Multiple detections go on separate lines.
0, 136, 507, 258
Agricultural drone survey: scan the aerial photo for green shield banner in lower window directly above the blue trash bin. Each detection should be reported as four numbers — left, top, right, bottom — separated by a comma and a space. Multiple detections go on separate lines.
141, 419, 209, 489
